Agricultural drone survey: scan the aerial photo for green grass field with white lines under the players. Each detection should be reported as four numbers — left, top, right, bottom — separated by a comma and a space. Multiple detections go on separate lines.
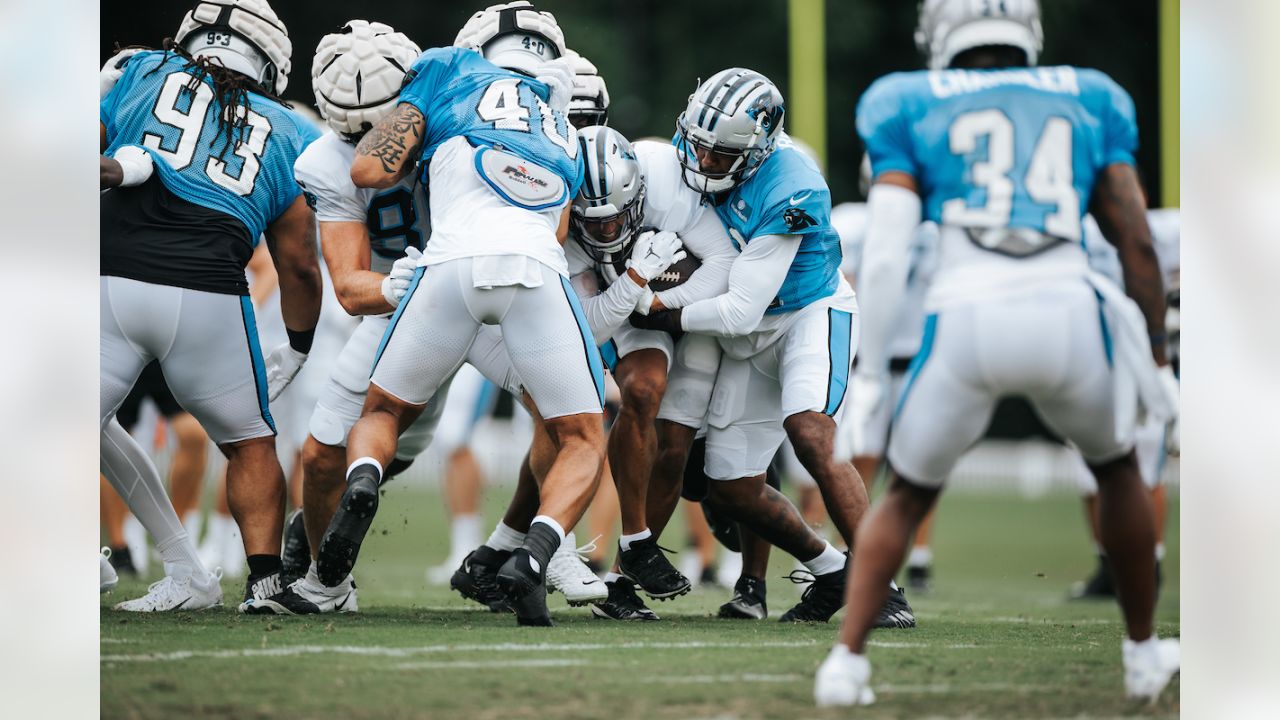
101, 487, 1179, 720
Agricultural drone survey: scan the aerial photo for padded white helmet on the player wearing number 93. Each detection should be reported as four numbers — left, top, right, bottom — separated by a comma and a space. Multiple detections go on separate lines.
174, 0, 293, 95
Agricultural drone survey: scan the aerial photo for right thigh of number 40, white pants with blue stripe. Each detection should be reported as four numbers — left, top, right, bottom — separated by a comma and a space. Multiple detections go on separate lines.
502, 266, 604, 419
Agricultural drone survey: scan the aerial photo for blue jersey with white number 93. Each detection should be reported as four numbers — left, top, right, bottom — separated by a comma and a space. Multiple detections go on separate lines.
100, 51, 320, 242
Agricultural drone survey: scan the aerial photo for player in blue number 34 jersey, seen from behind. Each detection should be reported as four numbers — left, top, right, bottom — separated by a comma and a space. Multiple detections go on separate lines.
814, 0, 1179, 706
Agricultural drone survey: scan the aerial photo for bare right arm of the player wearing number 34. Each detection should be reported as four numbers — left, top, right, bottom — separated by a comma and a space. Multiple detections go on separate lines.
1089, 163, 1169, 365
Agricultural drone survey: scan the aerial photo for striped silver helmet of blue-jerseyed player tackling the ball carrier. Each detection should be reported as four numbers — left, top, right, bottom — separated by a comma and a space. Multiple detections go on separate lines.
676, 68, 786, 195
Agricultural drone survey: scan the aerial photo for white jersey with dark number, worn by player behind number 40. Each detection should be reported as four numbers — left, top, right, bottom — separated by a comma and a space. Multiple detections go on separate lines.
293, 132, 431, 273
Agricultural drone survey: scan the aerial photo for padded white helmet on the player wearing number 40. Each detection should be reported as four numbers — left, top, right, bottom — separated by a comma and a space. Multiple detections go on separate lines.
453, 0, 564, 77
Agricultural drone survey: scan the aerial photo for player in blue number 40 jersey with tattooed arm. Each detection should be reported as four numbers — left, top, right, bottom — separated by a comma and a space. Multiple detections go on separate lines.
343, 1, 604, 624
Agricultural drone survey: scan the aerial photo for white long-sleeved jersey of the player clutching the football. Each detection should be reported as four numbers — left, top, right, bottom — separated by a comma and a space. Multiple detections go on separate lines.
564, 140, 737, 343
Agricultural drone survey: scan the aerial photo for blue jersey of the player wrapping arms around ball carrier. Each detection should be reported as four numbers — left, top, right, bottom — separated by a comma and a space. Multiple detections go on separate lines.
673, 135, 841, 315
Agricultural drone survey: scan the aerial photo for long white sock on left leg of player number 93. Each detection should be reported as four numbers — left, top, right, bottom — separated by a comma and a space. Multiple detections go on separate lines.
100, 418, 205, 575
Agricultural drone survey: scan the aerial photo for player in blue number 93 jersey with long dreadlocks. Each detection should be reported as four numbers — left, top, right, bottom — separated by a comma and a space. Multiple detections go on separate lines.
100, 0, 321, 611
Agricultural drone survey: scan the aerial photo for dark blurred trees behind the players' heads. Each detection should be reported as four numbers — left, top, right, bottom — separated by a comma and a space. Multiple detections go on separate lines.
101, 0, 1176, 202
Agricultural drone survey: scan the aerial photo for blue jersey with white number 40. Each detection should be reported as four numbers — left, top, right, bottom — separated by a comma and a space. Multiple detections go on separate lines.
399, 47, 582, 197
